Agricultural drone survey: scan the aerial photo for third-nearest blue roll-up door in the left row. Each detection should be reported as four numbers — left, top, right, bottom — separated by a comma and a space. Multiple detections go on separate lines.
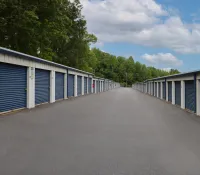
55, 72, 64, 100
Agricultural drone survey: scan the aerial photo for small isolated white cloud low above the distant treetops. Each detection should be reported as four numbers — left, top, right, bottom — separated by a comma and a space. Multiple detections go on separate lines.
142, 53, 183, 66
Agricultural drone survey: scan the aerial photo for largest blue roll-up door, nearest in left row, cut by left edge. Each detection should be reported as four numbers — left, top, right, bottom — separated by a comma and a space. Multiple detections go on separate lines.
0, 63, 27, 112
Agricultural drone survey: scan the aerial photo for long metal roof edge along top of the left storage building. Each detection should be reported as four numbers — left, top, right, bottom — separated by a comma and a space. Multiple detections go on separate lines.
0, 47, 94, 75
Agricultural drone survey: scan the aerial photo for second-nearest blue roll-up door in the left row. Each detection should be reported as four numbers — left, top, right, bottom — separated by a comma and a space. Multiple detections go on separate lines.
35, 69, 50, 105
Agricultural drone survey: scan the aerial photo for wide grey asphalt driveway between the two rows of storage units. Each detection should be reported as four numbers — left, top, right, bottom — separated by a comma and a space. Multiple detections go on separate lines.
0, 88, 200, 175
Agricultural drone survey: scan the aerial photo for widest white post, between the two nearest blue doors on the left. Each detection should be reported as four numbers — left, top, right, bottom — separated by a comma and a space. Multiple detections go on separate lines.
27, 67, 35, 109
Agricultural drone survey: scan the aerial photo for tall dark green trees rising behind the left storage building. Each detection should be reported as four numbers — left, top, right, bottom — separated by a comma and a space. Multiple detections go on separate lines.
0, 0, 97, 69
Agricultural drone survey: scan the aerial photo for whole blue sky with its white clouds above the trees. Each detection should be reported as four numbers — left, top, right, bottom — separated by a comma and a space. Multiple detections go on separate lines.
81, 0, 200, 72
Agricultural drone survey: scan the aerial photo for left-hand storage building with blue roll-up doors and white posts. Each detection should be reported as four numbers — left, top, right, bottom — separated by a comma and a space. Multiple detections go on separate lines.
0, 47, 116, 114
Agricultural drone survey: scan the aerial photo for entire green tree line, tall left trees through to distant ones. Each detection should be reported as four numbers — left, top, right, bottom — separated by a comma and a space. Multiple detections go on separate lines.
0, 0, 178, 85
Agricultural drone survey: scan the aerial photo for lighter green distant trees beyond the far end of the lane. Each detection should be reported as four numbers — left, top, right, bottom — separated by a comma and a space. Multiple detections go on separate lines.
91, 48, 179, 86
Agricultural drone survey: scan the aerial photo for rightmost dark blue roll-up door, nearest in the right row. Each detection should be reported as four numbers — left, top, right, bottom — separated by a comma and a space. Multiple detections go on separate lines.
185, 80, 196, 111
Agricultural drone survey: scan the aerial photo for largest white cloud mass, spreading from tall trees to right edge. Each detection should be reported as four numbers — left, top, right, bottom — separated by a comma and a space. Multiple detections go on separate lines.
81, 0, 200, 53
